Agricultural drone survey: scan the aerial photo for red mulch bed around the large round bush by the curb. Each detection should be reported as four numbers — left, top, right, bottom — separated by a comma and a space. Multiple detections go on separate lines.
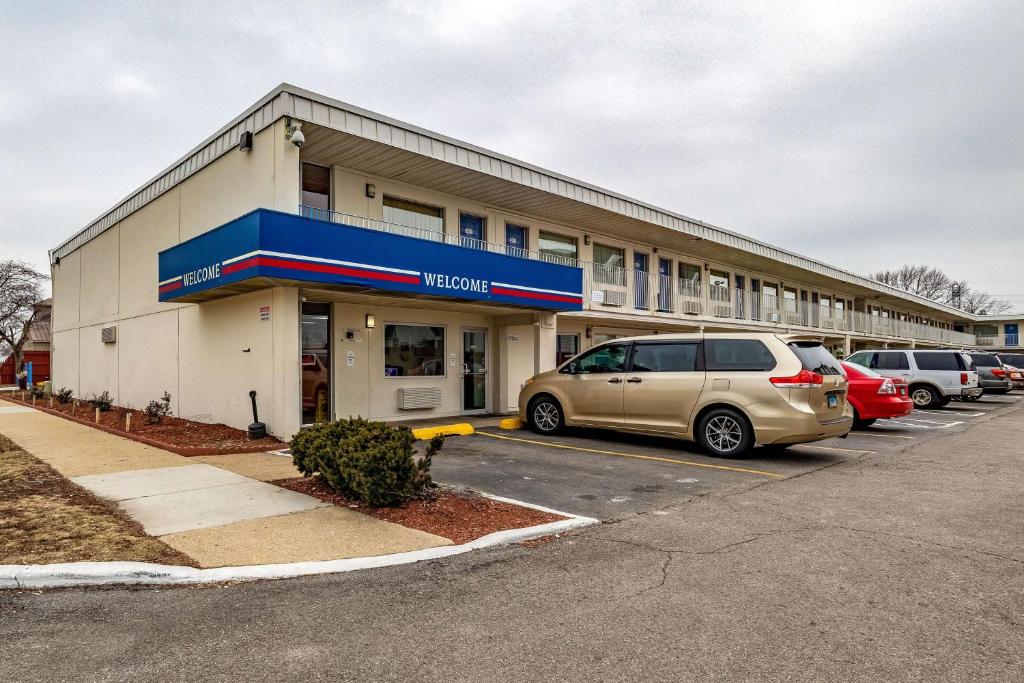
270, 477, 565, 545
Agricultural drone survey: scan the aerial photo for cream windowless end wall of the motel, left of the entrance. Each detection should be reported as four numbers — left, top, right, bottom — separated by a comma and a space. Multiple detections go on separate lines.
51, 121, 301, 437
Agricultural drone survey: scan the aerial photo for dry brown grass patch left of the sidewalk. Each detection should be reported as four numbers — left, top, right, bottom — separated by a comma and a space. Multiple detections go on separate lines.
0, 435, 195, 566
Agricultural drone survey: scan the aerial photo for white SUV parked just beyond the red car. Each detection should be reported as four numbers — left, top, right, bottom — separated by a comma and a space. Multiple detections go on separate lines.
846, 349, 982, 408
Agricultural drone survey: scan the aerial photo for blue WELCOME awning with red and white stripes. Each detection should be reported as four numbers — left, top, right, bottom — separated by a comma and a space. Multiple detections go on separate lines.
160, 209, 583, 310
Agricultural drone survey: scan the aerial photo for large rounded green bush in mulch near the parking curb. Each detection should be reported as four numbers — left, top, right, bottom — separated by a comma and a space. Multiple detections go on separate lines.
292, 418, 444, 507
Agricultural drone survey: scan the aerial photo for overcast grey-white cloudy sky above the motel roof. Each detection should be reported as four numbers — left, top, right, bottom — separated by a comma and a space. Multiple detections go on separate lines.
0, 0, 1024, 308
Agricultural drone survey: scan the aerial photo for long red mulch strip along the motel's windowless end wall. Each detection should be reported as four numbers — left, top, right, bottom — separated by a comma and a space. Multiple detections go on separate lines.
3, 392, 285, 457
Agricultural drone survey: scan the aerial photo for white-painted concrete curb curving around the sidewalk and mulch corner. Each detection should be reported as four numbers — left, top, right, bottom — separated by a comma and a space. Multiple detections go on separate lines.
0, 494, 599, 590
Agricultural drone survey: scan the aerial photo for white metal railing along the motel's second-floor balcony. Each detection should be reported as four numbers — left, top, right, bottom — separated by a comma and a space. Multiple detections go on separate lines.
299, 206, 978, 346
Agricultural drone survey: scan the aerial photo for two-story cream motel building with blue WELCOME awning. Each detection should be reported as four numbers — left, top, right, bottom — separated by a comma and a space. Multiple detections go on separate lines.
50, 84, 1017, 438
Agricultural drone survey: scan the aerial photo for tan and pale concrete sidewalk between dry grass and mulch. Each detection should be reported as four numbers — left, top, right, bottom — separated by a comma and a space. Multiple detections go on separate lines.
0, 400, 452, 567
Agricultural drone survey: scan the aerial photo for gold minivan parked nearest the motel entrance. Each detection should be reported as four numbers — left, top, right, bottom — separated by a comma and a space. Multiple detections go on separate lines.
519, 333, 853, 457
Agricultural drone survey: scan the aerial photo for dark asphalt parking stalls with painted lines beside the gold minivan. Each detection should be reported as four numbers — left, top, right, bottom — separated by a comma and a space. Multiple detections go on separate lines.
433, 394, 1020, 521
